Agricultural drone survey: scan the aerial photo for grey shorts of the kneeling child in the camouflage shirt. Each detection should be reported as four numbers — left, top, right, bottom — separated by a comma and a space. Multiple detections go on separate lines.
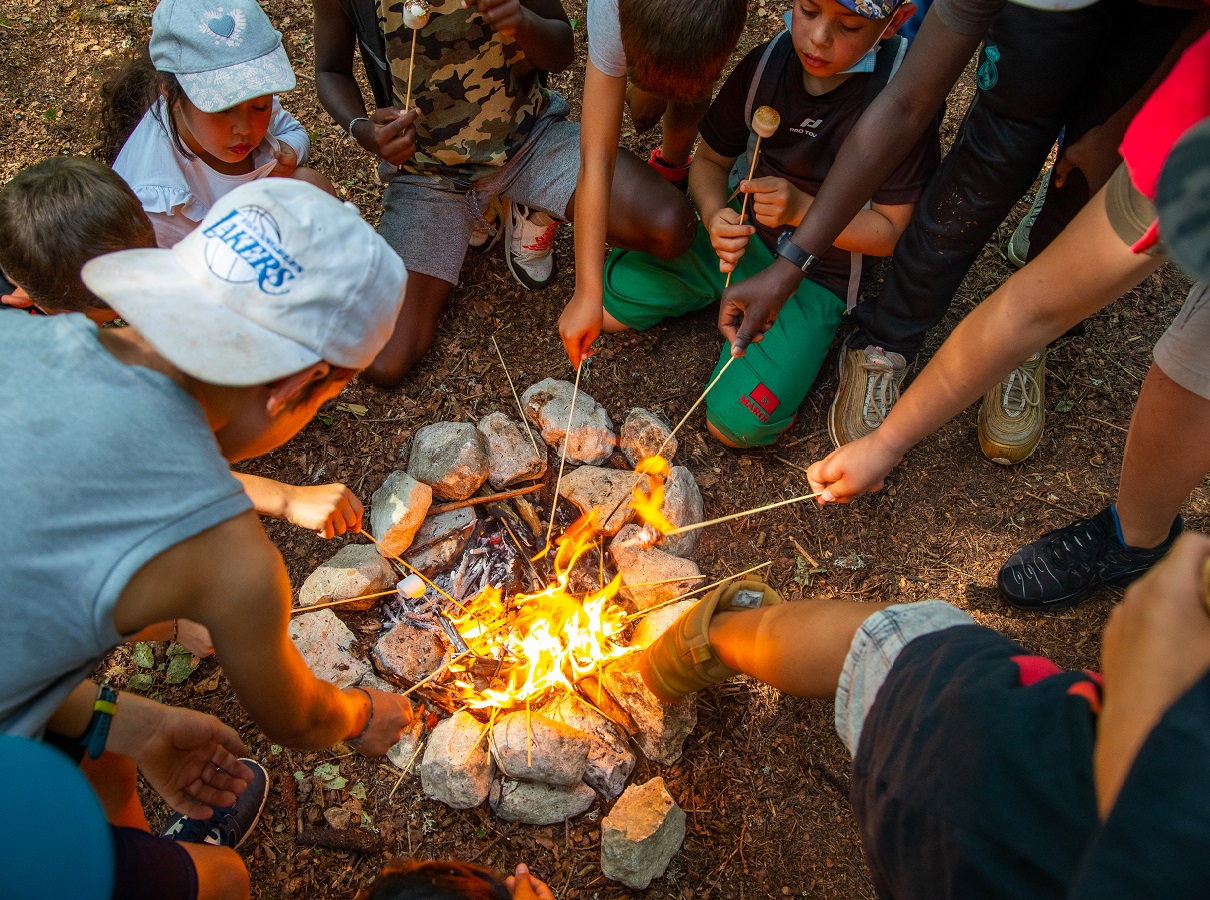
379, 93, 580, 284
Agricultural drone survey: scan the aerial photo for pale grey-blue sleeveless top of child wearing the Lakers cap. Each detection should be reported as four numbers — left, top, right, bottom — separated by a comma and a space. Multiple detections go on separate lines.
0, 313, 252, 738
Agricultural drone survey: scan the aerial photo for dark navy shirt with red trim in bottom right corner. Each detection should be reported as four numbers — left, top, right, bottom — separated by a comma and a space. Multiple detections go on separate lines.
851, 625, 1210, 900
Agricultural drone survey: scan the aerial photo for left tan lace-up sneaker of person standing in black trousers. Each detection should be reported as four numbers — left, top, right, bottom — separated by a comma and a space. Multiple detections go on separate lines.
828, 347, 908, 449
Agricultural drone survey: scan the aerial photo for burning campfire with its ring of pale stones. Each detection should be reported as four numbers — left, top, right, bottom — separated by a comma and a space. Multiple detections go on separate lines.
290, 367, 803, 885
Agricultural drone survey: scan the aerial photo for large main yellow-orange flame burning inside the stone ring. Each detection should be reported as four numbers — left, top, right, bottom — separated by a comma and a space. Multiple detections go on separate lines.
454, 510, 632, 709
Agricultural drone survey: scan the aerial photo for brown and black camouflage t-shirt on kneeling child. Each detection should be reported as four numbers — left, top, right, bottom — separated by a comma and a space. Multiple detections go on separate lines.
379, 0, 549, 190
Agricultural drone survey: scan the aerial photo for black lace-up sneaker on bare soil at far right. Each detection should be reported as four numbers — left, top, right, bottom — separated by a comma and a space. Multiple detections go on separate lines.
999, 507, 1183, 612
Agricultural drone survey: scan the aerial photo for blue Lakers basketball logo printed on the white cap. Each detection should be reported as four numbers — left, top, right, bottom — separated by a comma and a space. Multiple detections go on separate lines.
202, 206, 303, 294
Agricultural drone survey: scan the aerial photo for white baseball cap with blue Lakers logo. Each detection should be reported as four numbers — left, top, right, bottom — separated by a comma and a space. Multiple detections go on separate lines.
81, 178, 408, 386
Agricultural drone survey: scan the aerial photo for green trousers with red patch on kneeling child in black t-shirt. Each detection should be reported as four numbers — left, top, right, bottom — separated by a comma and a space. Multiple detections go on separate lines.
605, 216, 845, 446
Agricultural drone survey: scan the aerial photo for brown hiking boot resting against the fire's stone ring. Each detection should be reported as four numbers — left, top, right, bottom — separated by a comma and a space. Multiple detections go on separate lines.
639, 579, 782, 703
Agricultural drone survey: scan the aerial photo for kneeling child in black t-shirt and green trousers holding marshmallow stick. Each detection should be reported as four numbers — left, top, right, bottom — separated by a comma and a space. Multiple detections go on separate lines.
604, 0, 939, 446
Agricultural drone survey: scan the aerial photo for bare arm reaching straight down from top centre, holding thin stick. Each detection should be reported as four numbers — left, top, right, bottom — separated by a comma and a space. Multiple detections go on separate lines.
559, 59, 626, 367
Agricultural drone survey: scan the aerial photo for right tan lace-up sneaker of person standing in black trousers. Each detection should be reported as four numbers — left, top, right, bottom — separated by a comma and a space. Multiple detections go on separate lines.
979, 350, 1047, 466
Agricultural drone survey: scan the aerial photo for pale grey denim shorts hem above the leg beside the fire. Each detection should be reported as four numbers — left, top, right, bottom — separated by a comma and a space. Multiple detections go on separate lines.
836, 600, 974, 756
